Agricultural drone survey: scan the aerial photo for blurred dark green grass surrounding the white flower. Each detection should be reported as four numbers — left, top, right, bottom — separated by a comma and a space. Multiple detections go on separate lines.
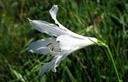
0, 0, 128, 82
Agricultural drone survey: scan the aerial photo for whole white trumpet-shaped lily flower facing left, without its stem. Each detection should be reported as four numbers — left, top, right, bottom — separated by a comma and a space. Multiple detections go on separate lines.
28, 5, 97, 75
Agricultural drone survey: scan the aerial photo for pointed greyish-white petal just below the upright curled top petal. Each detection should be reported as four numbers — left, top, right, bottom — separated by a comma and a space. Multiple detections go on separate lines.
29, 19, 68, 37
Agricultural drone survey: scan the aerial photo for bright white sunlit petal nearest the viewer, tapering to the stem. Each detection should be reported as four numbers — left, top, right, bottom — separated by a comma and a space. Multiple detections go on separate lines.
56, 35, 97, 52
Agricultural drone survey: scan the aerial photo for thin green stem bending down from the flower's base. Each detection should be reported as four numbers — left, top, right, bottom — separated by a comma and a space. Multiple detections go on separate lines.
97, 41, 122, 82
